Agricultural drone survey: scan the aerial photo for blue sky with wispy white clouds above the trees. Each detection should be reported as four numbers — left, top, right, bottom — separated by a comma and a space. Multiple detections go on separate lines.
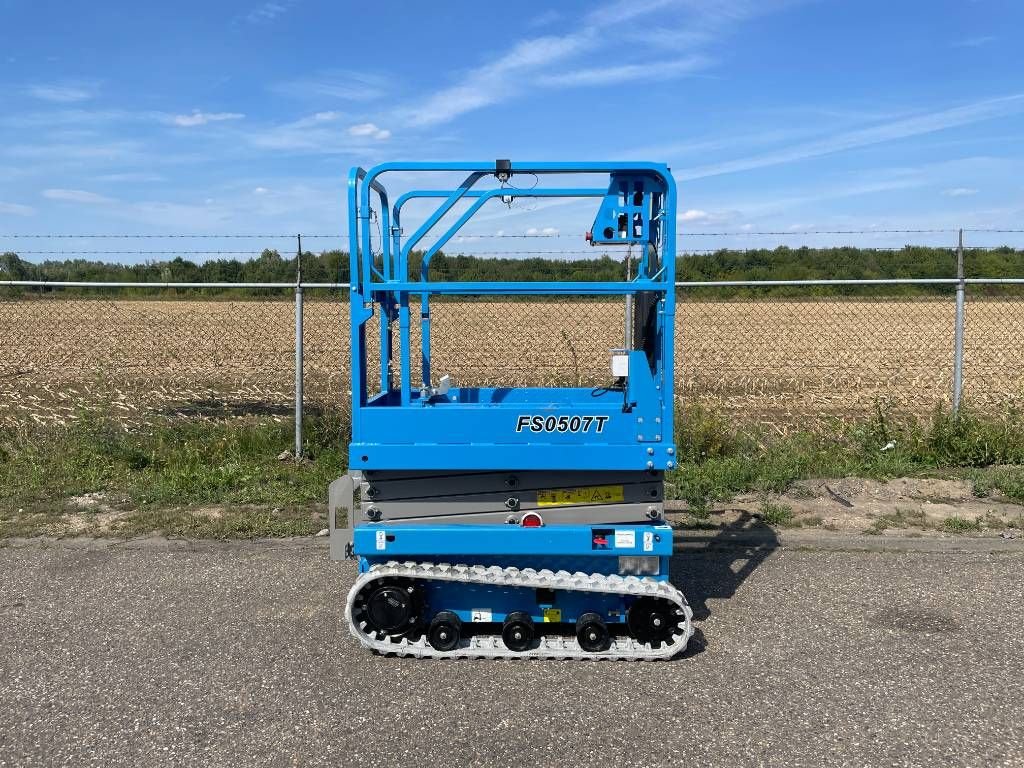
0, 0, 1024, 259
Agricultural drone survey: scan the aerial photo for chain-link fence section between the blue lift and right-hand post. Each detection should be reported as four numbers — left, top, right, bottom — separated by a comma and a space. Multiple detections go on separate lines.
676, 290, 954, 425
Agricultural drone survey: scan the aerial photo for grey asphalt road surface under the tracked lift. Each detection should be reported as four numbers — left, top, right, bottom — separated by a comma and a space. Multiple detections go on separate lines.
0, 543, 1024, 767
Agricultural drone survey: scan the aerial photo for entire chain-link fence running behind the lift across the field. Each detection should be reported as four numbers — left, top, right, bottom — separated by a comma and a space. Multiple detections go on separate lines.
0, 283, 1024, 428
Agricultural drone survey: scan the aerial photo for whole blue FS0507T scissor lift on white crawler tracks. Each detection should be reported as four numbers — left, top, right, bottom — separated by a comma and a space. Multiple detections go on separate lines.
329, 160, 691, 659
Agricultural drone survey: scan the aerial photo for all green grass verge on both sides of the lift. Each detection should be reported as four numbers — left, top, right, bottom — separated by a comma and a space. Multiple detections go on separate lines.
0, 409, 1024, 538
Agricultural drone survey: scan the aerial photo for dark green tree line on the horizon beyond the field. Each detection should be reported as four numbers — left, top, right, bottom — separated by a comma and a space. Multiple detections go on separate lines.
0, 246, 1024, 297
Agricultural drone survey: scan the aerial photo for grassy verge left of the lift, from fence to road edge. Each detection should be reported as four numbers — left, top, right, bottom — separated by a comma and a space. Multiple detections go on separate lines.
0, 416, 348, 537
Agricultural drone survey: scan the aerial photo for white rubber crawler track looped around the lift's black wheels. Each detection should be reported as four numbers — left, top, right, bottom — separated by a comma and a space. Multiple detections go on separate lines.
345, 561, 693, 662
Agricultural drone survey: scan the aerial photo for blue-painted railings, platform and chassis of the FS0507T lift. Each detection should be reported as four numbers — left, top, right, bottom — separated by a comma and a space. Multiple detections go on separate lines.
348, 163, 676, 624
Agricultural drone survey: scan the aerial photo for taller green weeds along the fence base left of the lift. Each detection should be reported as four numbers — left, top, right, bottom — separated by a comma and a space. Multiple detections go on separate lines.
0, 415, 346, 520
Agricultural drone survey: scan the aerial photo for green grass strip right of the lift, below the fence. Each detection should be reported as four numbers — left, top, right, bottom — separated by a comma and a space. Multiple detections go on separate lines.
668, 399, 1024, 512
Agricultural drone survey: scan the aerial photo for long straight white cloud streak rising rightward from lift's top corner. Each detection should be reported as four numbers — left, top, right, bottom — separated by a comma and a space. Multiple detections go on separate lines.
675, 93, 1024, 181
